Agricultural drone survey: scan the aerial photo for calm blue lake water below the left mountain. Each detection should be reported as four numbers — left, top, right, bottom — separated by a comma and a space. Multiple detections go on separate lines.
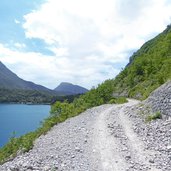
0, 104, 50, 147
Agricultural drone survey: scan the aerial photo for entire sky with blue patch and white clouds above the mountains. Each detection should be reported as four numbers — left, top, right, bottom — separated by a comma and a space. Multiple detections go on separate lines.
0, 0, 171, 89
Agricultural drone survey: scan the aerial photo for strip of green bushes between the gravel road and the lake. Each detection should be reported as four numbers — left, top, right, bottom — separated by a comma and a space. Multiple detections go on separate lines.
0, 80, 113, 163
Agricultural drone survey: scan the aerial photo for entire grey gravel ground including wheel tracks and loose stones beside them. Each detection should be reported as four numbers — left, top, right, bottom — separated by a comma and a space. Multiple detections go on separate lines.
0, 100, 171, 171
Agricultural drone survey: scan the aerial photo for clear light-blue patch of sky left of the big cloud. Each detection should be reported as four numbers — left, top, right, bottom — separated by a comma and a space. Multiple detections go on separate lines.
0, 0, 52, 54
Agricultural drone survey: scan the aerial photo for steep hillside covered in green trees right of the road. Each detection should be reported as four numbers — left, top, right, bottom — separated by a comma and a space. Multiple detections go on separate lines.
112, 25, 171, 99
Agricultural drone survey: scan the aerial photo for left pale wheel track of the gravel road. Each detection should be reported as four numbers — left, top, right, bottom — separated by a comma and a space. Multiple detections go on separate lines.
93, 106, 127, 171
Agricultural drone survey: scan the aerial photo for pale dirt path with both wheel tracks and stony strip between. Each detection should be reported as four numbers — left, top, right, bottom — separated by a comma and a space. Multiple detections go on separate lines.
93, 100, 159, 171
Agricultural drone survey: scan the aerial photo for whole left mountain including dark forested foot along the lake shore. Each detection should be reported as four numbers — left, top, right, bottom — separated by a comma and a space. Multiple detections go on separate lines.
0, 62, 79, 104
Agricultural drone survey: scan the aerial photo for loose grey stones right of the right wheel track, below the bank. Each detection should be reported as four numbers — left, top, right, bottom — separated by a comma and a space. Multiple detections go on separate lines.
128, 103, 171, 171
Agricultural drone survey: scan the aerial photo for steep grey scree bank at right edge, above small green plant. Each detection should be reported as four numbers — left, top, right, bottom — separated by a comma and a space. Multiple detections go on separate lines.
147, 81, 171, 116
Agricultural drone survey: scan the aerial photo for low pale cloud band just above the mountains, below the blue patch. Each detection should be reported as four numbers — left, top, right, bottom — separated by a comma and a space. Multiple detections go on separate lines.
0, 44, 118, 88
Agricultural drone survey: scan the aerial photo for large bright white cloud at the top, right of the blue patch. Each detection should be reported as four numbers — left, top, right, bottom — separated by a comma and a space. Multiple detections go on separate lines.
23, 0, 171, 47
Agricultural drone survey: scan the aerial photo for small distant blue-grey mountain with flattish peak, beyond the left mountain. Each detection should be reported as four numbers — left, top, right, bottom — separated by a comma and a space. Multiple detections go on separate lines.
54, 82, 88, 95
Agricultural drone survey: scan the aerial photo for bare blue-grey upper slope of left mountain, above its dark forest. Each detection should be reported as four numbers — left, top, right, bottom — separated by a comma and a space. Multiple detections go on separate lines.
0, 62, 52, 92
